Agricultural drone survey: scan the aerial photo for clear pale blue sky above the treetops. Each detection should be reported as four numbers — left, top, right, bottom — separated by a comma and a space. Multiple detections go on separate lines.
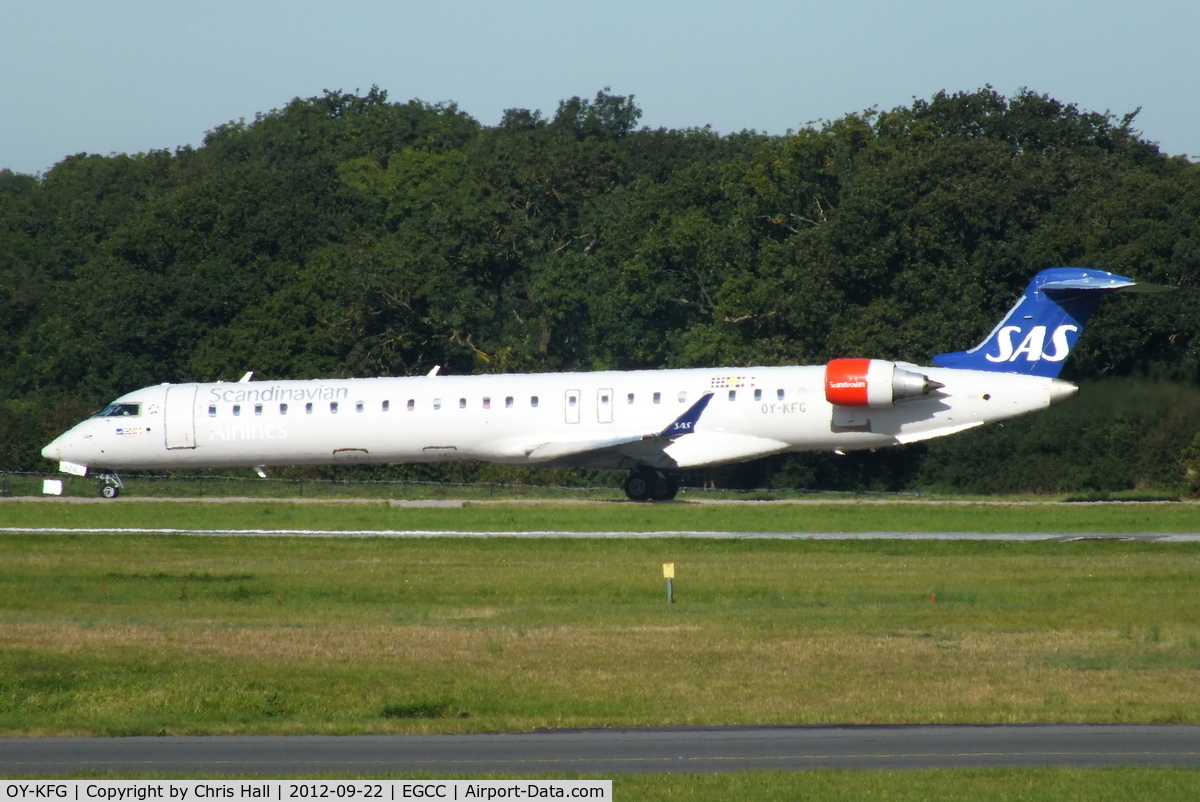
0, 0, 1200, 173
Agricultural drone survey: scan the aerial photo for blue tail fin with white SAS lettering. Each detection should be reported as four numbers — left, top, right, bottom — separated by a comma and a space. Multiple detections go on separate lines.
934, 268, 1163, 378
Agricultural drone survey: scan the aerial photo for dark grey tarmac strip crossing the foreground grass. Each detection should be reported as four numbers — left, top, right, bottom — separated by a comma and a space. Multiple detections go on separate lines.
0, 724, 1200, 776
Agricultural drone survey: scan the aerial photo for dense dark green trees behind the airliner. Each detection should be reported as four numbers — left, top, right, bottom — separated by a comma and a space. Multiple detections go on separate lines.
0, 88, 1200, 491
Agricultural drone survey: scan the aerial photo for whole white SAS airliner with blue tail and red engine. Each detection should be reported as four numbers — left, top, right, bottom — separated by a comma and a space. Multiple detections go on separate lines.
42, 268, 1154, 501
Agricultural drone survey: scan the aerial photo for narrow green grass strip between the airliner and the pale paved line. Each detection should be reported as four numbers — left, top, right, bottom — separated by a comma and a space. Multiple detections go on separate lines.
7, 499, 1200, 533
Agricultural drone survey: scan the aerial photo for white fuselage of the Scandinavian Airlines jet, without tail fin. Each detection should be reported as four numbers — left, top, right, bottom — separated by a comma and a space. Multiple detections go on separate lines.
43, 365, 1075, 471
